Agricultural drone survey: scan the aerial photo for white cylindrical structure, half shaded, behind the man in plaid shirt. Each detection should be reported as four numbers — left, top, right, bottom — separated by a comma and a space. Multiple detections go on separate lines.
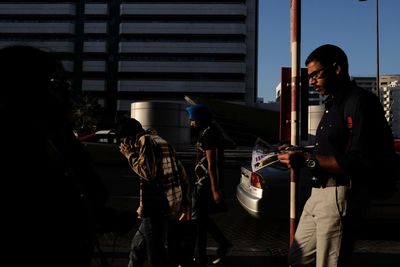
131, 101, 190, 150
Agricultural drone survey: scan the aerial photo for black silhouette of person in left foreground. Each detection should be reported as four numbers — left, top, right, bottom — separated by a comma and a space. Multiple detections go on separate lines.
0, 45, 133, 267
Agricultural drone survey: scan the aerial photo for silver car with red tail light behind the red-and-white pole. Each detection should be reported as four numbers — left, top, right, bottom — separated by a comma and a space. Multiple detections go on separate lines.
236, 147, 400, 223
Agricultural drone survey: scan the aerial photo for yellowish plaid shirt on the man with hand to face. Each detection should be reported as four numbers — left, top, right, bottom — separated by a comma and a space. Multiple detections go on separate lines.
129, 130, 188, 220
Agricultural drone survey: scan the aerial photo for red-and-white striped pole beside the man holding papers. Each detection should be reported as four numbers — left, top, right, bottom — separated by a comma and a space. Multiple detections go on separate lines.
290, 0, 301, 245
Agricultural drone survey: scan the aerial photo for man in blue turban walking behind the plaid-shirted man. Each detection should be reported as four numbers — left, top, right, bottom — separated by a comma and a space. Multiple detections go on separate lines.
186, 104, 232, 266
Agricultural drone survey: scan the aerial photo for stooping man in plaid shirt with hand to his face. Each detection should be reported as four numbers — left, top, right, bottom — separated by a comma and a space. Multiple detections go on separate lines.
118, 118, 188, 267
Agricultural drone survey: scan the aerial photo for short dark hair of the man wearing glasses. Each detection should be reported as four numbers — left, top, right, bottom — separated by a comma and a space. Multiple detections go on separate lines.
305, 44, 349, 74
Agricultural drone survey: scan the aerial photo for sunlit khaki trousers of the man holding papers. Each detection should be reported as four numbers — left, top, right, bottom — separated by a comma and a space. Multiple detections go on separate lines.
289, 186, 349, 267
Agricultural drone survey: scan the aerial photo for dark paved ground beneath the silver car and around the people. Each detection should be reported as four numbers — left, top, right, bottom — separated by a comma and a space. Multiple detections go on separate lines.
93, 199, 400, 267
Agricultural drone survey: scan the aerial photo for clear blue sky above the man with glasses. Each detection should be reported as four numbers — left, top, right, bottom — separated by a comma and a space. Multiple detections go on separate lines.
258, 0, 400, 102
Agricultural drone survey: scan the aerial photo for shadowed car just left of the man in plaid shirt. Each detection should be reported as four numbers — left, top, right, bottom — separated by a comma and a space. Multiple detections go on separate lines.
78, 129, 126, 163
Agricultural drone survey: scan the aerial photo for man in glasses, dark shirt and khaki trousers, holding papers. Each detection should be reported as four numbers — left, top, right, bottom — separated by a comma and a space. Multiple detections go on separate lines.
278, 44, 394, 267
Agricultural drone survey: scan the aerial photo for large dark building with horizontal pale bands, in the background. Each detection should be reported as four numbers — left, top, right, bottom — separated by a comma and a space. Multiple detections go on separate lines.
0, 0, 258, 126
